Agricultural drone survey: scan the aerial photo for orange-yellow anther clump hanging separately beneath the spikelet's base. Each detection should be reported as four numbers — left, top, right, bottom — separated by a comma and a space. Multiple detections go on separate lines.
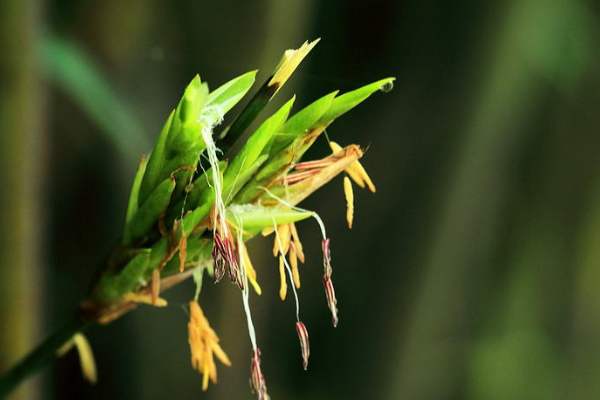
188, 301, 231, 390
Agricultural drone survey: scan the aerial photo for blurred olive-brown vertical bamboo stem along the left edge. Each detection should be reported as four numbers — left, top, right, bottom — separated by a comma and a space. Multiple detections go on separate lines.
0, 0, 44, 400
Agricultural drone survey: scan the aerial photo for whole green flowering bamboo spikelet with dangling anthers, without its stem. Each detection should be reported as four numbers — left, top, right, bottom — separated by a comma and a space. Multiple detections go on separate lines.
11, 40, 394, 400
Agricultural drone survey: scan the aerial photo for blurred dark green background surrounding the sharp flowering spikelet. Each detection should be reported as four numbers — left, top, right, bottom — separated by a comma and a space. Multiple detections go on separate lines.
0, 0, 600, 400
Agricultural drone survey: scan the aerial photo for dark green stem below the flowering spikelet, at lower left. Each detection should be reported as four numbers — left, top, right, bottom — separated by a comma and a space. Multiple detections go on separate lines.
0, 315, 91, 399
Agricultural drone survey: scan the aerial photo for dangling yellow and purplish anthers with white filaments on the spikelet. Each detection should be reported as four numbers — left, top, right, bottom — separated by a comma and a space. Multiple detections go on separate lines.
189, 137, 376, 400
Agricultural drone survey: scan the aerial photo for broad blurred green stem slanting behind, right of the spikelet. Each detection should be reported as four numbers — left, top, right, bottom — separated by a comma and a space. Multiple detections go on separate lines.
388, 1, 552, 399
